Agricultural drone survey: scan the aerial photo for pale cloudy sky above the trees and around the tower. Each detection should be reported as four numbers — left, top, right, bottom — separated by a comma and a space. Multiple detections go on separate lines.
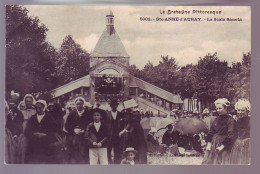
25, 5, 251, 69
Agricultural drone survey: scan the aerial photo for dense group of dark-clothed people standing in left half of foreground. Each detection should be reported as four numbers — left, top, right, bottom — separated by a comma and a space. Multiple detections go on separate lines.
6, 94, 147, 165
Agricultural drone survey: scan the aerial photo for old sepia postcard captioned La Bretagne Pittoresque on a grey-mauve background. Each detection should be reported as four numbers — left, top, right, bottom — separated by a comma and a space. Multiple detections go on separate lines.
5, 5, 251, 165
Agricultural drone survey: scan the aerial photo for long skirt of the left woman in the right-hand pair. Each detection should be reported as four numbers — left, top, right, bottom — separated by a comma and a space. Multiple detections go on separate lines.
202, 135, 231, 164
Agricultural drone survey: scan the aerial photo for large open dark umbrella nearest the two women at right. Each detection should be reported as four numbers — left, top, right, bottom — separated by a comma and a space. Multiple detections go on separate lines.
175, 118, 208, 135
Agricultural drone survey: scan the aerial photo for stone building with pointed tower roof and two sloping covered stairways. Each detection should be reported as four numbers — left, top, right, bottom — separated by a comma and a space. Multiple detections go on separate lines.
48, 12, 183, 115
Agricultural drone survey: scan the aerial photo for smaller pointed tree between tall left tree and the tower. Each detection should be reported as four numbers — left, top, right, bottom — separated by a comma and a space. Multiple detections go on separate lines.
56, 35, 90, 85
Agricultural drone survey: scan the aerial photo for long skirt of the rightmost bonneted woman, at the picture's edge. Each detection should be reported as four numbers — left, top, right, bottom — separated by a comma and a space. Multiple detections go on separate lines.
230, 138, 251, 165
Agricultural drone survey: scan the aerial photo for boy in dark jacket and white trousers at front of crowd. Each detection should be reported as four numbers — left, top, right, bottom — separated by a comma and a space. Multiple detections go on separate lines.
85, 108, 108, 165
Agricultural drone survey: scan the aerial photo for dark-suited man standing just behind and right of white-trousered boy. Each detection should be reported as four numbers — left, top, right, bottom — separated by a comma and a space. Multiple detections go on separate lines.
105, 100, 123, 164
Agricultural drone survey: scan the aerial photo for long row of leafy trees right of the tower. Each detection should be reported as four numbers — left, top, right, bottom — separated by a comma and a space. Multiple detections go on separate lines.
130, 53, 251, 107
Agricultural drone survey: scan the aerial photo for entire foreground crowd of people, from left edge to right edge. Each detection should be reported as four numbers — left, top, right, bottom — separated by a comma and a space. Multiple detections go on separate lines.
5, 94, 251, 165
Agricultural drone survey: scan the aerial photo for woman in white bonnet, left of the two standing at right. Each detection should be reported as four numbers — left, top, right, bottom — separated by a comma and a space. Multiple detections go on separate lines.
202, 98, 237, 164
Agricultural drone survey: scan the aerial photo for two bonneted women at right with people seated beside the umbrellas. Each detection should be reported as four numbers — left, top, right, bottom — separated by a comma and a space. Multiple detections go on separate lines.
144, 98, 251, 165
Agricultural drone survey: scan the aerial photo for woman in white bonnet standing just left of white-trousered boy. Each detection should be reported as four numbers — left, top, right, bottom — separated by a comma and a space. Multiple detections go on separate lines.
65, 97, 93, 164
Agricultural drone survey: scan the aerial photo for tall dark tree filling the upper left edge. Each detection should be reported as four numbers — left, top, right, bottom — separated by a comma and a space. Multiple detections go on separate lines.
6, 5, 55, 93
